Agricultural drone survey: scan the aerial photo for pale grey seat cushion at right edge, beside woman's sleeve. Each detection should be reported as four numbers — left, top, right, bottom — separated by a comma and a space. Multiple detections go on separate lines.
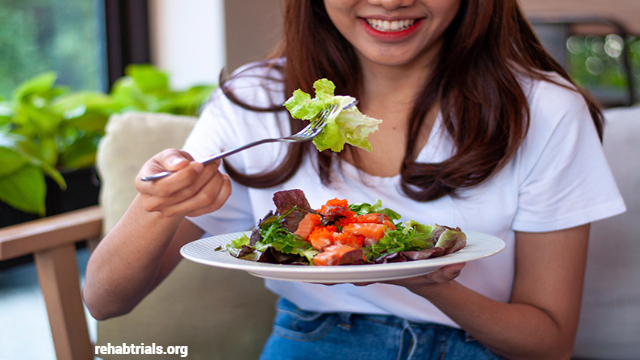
574, 107, 640, 360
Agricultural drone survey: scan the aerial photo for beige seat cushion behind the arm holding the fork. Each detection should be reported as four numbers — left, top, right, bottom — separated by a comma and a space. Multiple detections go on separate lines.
97, 113, 276, 360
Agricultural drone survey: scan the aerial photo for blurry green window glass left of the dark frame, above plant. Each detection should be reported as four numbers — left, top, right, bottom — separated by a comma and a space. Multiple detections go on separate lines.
0, 0, 107, 98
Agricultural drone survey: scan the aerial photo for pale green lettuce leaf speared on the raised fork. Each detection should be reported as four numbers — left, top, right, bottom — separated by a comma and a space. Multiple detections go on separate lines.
284, 79, 382, 152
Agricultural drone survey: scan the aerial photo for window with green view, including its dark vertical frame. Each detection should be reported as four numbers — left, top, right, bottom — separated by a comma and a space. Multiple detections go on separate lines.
0, 0, 150, 99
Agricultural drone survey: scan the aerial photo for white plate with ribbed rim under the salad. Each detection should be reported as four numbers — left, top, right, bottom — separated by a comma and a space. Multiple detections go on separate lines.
180, 231, 505, 283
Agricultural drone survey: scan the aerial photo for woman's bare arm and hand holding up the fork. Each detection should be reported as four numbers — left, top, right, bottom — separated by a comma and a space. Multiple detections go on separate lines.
83, 150, 231, 320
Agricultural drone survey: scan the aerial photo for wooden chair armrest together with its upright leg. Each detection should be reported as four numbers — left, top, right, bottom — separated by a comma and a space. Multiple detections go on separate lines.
0, 206, 102, 360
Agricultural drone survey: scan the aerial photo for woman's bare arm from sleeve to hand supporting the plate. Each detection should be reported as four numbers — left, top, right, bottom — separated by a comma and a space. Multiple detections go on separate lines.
392, 225, 589, 359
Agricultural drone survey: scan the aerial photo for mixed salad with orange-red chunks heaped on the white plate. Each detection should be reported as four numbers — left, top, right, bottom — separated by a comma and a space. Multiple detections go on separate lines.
216, 190, 466, 266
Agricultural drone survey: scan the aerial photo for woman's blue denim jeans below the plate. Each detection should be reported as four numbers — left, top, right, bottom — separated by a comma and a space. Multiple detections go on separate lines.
260, 299, 503, 360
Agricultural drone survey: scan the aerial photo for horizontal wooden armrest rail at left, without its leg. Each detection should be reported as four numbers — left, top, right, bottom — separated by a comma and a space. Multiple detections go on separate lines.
0, 206, 102, 260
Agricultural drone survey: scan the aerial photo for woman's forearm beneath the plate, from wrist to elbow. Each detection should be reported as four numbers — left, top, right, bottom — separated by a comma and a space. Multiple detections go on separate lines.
412, 281, 573, 360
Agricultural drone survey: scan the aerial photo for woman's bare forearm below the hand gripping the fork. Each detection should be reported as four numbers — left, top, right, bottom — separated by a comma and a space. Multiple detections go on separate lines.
83, 198, 188, 318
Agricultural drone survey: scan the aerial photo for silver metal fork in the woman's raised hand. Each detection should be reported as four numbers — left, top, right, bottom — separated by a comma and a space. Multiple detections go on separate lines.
141, 101, 357, 181
